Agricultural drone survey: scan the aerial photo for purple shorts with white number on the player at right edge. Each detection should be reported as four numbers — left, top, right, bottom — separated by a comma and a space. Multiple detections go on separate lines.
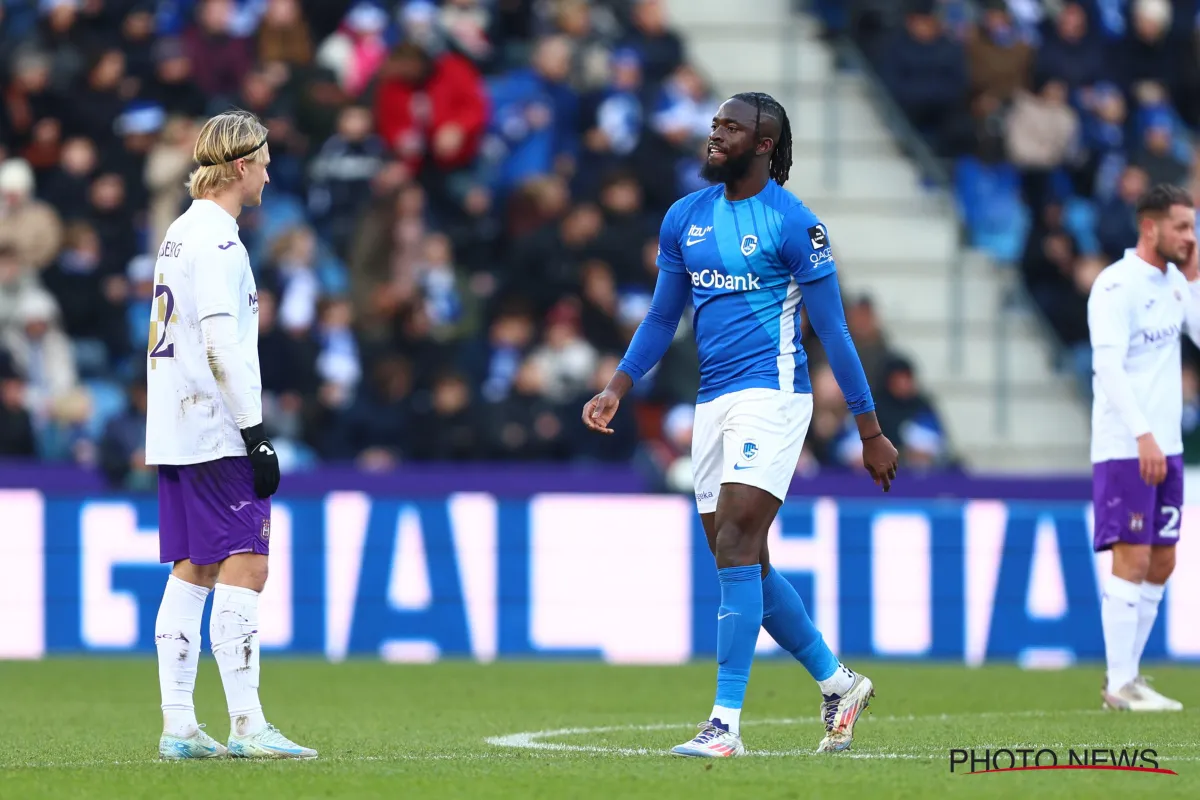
1092, 456, 1183, 553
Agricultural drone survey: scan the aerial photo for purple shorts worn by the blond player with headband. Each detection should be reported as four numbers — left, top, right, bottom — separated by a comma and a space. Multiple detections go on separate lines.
158, 456, 271, 564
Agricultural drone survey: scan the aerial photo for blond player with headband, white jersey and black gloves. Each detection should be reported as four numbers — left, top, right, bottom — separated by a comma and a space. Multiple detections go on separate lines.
145, 112, 317, 759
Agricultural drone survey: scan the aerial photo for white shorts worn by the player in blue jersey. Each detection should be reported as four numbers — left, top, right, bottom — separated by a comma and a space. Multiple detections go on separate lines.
691, 389, 812, 513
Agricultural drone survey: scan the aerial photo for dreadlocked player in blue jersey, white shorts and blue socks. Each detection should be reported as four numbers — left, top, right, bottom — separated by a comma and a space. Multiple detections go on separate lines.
583, 92, 896, 758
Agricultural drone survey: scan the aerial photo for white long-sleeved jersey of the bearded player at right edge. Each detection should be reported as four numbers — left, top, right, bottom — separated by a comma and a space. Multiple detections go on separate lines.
1087, 249, 1198, 463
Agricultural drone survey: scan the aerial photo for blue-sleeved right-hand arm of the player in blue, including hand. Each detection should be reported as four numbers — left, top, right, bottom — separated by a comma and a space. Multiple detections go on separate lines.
780, 205, 898, 492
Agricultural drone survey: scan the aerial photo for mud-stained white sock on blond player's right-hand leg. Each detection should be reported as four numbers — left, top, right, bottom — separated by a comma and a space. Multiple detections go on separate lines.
210, 583, 266, 736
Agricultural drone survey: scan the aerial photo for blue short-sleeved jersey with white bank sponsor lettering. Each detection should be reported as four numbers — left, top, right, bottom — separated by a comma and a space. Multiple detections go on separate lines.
658, 181, 835, 403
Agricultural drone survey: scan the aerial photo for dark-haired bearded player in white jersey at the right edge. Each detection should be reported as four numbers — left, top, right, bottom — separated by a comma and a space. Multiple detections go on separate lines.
1087, 186, 1200, 711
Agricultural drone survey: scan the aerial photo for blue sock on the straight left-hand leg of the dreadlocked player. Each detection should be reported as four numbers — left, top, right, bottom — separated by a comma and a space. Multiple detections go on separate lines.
715, 564, 763, 733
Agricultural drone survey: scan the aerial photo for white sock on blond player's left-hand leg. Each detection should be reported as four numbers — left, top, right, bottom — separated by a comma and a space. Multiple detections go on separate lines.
154, 576, 209, 739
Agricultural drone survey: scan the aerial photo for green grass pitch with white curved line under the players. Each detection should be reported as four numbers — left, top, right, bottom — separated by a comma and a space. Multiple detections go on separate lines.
0, 655, 1200, 800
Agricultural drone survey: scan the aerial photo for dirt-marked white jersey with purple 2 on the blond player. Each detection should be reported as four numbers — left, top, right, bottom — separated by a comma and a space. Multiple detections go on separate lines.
145, 200, 262, 464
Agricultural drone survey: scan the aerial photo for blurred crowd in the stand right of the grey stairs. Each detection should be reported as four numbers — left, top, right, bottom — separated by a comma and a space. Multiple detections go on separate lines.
814, 0, 1200, 458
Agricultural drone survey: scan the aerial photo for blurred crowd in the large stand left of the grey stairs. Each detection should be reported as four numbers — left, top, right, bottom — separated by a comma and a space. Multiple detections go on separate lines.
0, 0, 947, 491
